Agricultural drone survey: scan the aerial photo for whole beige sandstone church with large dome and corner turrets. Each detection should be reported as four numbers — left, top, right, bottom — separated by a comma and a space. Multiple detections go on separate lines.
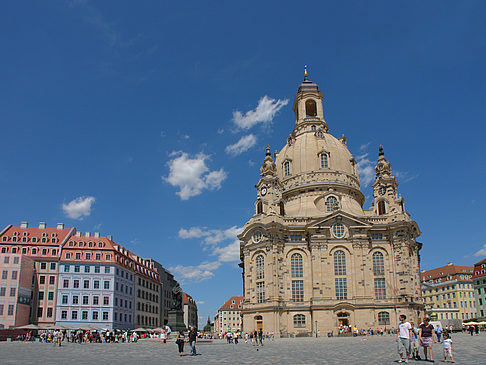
238, 72, 424, 337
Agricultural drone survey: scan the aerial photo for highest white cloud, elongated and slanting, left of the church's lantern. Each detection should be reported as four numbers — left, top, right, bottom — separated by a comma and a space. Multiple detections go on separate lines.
233, 95, 289, 129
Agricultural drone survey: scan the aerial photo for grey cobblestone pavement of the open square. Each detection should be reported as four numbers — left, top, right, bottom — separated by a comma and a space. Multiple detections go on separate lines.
0, 334, 486, 365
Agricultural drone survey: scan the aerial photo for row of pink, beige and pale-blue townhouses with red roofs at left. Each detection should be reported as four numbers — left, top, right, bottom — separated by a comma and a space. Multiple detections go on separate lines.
0, 222, 188, 329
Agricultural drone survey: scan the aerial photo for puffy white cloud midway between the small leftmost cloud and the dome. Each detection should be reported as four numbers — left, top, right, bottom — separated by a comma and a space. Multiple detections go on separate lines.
162, 151, 227, 200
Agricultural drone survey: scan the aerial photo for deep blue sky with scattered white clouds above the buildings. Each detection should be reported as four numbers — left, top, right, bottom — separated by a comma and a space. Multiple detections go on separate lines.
0, 0, 486, 322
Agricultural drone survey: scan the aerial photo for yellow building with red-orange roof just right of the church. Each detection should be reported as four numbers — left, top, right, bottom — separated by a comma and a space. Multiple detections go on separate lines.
421, 262, 476, 329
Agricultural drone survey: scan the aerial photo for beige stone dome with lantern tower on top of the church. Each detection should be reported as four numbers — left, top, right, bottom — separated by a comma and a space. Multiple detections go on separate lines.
275, 71, 364, 216
